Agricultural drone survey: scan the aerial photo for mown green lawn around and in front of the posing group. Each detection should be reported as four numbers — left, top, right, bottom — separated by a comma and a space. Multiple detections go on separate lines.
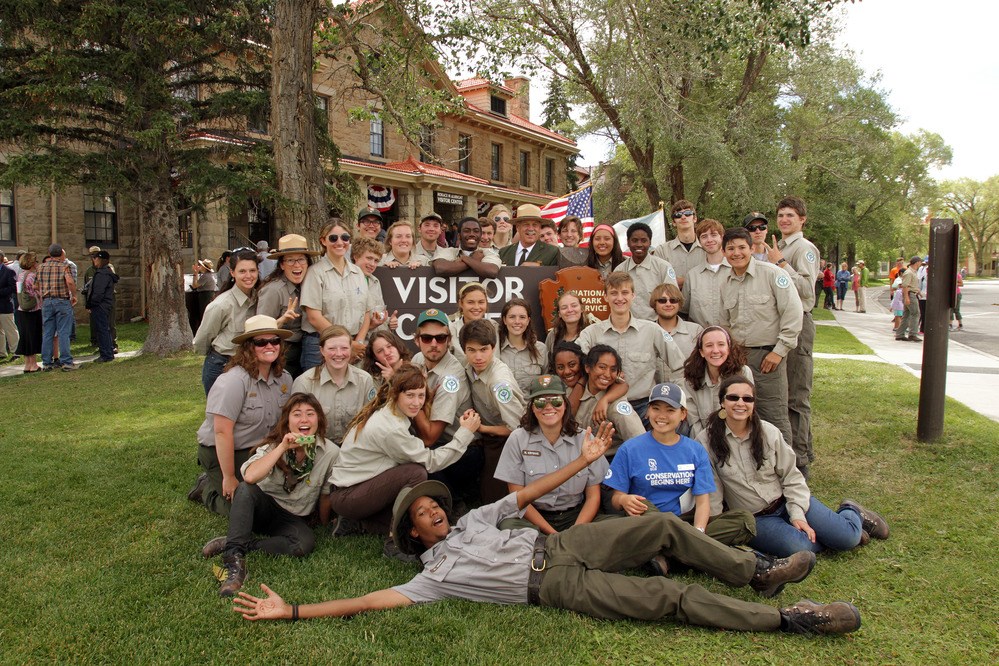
0, 355, 999, 665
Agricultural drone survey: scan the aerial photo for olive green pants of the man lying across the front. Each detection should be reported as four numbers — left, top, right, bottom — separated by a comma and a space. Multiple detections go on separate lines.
541, 513, 780, 631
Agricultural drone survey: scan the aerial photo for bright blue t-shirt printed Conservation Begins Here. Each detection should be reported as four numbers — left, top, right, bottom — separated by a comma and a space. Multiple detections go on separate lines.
604, 432, 715, 516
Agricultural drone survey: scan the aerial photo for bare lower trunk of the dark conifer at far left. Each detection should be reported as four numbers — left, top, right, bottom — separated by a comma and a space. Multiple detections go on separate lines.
140, 175, 193, 356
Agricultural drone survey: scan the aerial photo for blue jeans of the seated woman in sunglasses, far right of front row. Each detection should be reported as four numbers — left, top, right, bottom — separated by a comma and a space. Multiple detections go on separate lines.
749, 496, 861, 557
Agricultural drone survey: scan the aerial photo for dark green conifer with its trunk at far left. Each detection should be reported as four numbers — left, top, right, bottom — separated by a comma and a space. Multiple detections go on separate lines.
0, 0, 273, 354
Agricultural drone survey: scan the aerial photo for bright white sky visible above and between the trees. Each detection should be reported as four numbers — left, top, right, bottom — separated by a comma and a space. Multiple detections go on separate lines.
564, 0, 999, 180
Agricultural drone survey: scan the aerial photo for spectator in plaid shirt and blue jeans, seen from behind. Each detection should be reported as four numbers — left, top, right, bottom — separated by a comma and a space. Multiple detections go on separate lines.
38, 243, 76, 371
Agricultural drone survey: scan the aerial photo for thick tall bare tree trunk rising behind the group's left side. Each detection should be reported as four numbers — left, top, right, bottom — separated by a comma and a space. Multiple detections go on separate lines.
271, 0, 327, 238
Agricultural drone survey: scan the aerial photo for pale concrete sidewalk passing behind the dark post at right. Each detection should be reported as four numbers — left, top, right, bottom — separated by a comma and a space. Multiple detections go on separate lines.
815, 287, 999, 421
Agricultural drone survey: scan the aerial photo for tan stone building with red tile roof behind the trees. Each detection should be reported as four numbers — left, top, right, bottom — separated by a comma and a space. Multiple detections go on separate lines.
0, 56, 577, 320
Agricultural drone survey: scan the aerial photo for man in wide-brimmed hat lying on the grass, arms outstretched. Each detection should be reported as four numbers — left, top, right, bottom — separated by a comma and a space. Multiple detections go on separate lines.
233, 422, 860, 634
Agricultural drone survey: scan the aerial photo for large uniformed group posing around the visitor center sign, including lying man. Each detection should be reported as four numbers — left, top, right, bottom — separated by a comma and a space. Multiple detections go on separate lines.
189, 197, 888, 633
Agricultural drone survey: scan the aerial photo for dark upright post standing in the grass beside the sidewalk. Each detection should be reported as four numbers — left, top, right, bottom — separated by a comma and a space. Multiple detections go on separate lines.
916, 220, 958, 442
